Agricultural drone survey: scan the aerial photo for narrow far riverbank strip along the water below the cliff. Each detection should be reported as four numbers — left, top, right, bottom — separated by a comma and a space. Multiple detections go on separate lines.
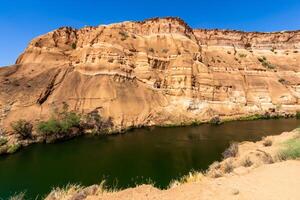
0, 112, 300, 156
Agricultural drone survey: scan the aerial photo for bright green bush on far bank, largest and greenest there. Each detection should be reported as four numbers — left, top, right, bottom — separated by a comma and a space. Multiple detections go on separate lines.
37, 112, 80, 135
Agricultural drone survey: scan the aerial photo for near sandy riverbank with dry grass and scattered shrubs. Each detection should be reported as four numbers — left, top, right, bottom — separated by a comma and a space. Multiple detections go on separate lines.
46, 129, 300, 200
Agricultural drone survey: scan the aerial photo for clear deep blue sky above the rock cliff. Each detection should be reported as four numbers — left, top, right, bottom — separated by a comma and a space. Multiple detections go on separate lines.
0, 0, 300, 66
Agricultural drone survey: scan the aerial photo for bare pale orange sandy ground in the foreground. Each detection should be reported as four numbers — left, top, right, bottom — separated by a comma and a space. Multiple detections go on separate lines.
87, 161, 300, 200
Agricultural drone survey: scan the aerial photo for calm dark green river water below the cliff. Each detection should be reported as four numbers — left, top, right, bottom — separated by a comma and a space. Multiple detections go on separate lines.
0, 119, 300, 199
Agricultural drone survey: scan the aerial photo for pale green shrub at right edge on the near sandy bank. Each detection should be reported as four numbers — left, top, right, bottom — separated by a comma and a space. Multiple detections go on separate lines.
278, 137, 300, 160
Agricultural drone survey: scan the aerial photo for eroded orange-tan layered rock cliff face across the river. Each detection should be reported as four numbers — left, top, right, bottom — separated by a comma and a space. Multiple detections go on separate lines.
0, 18, 300, 131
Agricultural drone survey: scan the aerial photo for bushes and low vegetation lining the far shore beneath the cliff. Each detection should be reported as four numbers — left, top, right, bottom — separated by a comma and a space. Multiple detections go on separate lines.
0, 108, 300, 156
